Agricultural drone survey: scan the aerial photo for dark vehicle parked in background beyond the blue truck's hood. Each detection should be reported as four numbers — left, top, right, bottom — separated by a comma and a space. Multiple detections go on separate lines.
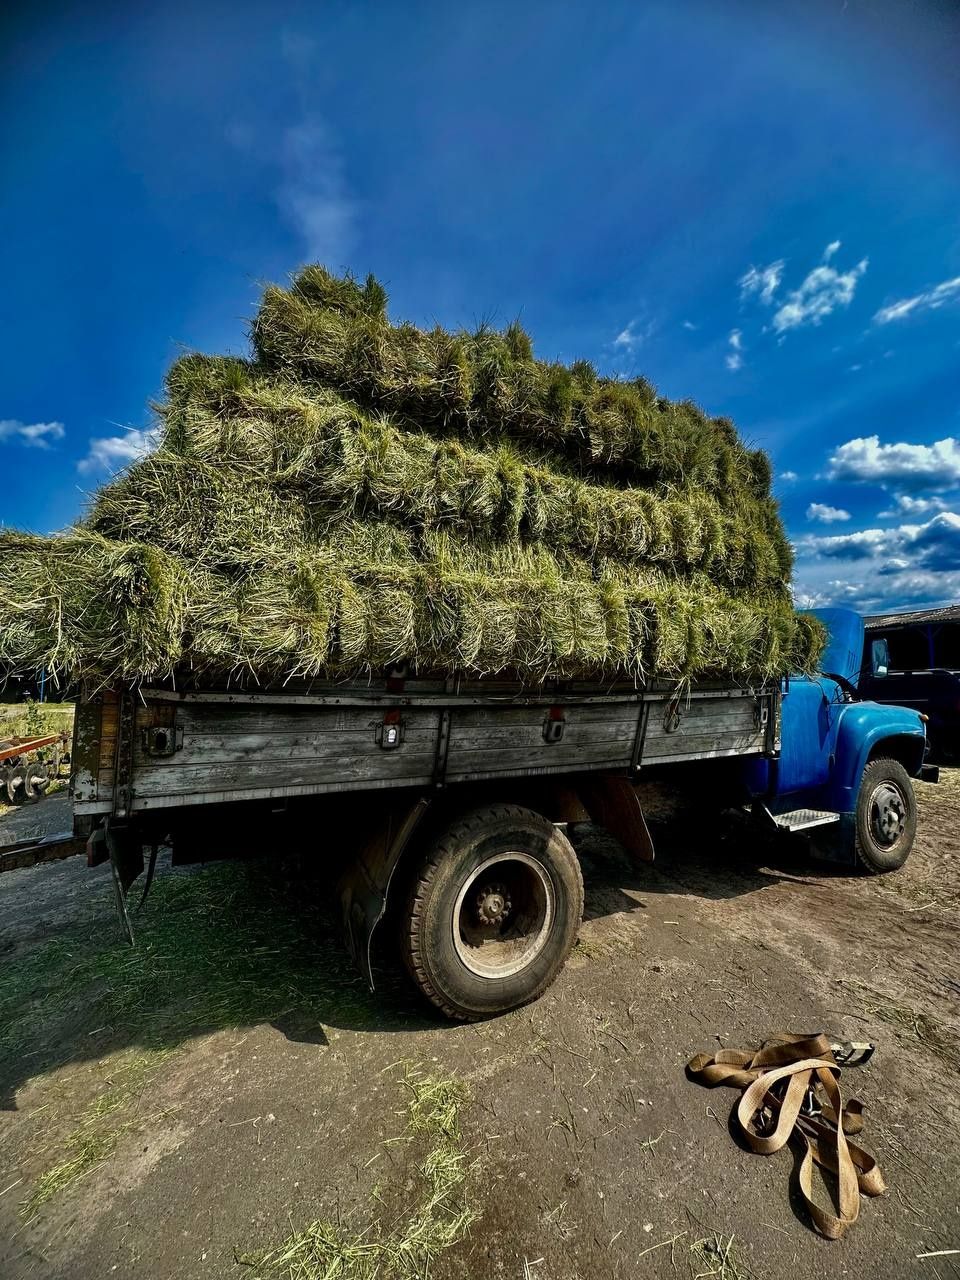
859, 604, 960, 759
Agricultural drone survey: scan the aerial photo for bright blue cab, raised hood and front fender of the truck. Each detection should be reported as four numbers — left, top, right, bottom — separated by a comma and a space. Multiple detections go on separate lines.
746, 609, 925, 814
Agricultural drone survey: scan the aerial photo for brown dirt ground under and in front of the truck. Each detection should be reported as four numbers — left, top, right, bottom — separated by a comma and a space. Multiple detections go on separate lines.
0, 771, 960, 1280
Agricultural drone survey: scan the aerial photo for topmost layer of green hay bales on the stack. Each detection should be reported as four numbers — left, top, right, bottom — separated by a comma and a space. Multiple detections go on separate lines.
252, 282, 769, 497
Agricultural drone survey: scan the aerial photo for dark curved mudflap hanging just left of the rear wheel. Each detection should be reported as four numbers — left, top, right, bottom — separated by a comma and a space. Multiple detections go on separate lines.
339, 796, 430, 991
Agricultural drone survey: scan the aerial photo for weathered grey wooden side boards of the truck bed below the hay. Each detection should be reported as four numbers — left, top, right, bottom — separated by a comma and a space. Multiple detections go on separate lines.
72, 678, 780, 817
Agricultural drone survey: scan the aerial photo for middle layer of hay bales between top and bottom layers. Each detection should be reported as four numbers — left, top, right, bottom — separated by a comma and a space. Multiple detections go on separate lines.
86, 407, 790, 591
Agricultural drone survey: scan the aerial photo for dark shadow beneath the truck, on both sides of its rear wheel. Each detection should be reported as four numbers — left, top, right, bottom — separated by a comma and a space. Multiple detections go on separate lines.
0, 823, 855, 1110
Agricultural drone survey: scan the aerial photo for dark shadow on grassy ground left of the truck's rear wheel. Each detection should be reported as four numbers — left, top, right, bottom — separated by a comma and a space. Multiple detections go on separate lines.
0, 860, 435, 1110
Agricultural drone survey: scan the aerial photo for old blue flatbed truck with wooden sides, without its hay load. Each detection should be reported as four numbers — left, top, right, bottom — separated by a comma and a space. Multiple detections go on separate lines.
0, 609, 925, 1019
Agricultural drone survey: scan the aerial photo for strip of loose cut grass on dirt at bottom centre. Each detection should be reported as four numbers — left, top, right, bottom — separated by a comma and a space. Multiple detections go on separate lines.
237, 1066, 477, 1280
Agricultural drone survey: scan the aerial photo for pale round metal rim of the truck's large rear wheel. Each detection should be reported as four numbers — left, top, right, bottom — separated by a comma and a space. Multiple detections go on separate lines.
453, 852, 556, 978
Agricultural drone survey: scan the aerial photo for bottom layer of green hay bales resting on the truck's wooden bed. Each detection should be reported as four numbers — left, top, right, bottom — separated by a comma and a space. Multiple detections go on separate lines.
0, 521, 815, 680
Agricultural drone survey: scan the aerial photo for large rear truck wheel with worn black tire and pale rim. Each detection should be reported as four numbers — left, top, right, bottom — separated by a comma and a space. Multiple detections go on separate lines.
402, 804, 584, 1021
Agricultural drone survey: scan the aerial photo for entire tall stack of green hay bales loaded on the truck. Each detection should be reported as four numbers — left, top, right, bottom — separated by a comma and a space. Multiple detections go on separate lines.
0, 266, 823, 681
